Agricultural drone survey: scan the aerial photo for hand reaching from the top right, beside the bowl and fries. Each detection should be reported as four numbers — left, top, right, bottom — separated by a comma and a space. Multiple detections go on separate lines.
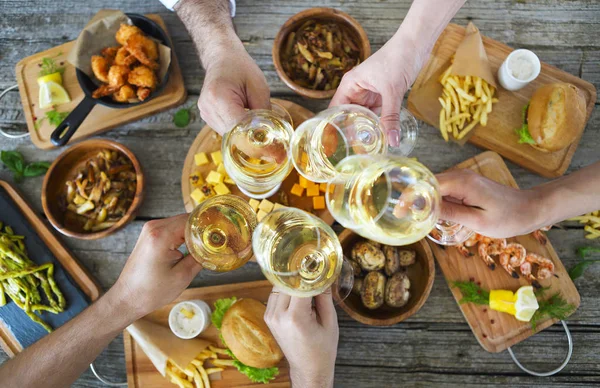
329, 34, 426, 146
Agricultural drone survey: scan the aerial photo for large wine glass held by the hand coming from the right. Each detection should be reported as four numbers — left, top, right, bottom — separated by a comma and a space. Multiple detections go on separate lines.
325, 155, 472, 245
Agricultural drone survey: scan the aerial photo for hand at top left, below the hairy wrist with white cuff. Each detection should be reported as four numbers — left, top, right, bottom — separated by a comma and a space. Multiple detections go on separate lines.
198, 42, 271, 135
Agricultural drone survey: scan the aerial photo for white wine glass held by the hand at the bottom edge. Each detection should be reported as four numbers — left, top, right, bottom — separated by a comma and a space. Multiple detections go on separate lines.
252, 207, 354, 303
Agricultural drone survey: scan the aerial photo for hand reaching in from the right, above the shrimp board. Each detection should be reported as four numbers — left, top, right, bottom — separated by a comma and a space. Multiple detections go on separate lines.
436, 169, 547, 238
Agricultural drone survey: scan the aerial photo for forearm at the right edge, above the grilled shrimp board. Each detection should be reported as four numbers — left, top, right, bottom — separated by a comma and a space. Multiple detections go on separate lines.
532, 162, 600, 226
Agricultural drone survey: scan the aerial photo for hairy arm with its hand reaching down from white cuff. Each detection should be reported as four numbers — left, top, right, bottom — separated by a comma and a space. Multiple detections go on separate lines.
175, 0, 270, 134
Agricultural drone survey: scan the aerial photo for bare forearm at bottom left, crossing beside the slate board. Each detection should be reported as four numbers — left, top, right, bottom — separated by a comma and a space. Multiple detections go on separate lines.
0, 291, 137, 388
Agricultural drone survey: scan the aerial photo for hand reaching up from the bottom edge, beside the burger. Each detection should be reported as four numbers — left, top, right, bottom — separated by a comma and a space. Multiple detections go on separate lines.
265, 288, 339, 388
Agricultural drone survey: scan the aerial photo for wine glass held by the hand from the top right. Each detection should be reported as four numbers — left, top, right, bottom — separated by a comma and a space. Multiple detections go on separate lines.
291, 104, 418, 183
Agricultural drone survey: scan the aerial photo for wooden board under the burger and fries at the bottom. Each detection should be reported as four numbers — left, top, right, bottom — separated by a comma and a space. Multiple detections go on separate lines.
123, 280, 291, 388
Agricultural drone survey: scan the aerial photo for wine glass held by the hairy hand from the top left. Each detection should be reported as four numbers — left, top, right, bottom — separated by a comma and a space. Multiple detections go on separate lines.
221, 104, 294, 199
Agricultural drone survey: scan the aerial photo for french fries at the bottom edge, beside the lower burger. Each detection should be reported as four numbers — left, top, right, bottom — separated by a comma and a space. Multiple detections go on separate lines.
166, 346, 233, 388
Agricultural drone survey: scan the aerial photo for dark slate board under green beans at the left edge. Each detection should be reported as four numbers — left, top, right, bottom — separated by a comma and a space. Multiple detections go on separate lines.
0, 187, 90, 348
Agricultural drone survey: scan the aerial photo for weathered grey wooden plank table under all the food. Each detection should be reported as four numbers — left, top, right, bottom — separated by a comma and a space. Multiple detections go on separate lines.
0, 0, 600, 387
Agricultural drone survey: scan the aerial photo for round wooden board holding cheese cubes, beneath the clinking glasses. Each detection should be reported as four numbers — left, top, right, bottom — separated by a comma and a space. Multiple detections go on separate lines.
181, 99, 334, 225
